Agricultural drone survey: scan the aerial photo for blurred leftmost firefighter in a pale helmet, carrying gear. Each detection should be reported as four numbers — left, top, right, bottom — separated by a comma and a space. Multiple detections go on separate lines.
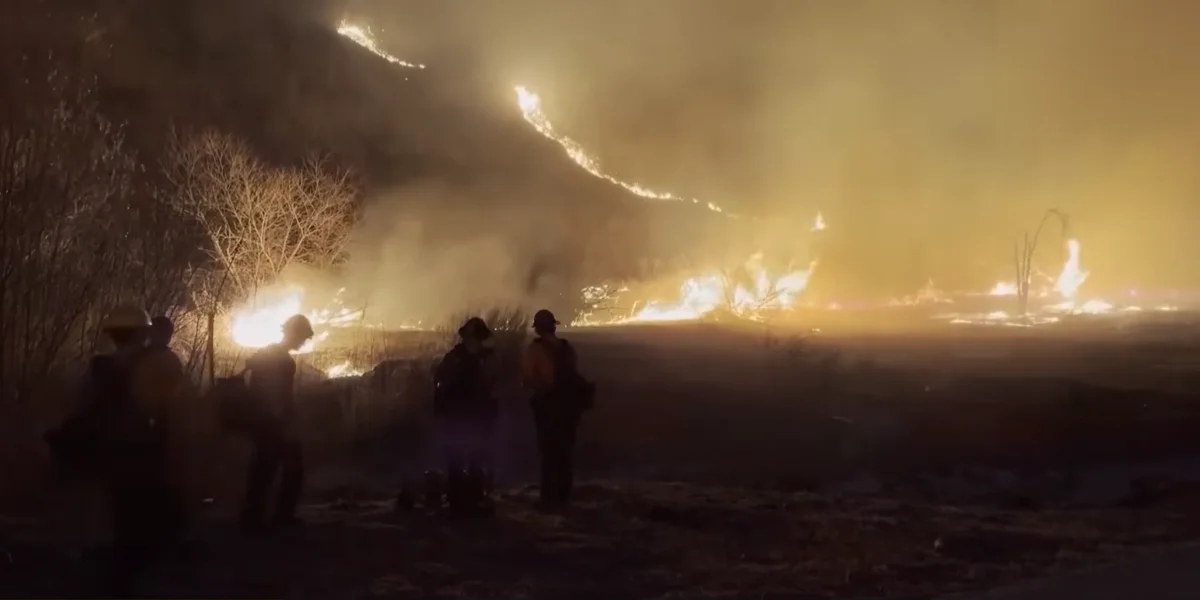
47, 306, 185, 596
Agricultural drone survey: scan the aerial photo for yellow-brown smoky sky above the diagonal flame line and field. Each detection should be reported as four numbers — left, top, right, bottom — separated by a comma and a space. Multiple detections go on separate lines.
333, 0, 1200, 298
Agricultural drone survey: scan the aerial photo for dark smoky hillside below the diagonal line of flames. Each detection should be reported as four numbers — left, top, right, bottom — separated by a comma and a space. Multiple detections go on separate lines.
0, 0, 728, 292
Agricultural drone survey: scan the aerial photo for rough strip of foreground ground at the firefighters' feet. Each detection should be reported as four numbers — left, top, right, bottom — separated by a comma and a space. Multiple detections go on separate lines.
7, 484, 1200, 598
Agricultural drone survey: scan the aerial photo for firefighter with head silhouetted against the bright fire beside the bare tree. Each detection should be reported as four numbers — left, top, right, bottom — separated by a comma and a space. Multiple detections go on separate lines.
241, 314, 313, 532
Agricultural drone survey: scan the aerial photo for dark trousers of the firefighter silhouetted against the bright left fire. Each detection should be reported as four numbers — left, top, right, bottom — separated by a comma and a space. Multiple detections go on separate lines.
241, 433, 304, 527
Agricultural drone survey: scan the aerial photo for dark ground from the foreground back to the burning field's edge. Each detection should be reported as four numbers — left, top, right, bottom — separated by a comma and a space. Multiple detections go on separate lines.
0, 323, 1200, 598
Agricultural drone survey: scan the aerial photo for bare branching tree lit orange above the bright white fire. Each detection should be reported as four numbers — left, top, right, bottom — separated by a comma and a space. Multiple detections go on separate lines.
166, 132, 355, 296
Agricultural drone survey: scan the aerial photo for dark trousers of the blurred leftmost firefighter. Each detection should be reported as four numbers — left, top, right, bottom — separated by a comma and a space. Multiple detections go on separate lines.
108, 473, 185, 598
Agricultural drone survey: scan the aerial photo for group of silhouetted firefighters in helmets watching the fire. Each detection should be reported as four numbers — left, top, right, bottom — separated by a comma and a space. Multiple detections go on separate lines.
46, 306, 594, 596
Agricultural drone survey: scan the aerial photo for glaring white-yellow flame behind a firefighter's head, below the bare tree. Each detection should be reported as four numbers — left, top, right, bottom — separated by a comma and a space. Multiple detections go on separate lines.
229, 286, 362, 354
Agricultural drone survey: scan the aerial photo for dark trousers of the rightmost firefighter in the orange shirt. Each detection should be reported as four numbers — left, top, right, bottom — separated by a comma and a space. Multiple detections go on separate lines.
533, 403, 580, 506
